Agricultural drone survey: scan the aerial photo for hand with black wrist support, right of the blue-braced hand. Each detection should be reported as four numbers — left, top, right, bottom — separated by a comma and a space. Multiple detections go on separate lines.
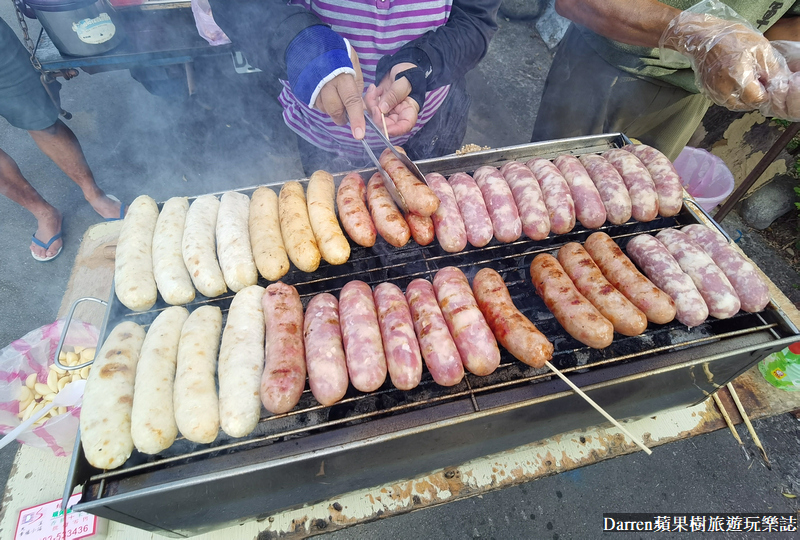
364, 62, 419, 137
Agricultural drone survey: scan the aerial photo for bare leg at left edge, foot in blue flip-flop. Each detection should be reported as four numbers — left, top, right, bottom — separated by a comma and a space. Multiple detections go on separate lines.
0, 149, 64, 257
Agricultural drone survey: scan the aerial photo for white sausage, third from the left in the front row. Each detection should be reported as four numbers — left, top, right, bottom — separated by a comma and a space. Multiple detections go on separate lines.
173, 306, 222, 443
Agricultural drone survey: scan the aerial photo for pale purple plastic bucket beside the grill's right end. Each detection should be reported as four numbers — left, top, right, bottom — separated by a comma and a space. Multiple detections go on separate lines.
674, 146, 734, 212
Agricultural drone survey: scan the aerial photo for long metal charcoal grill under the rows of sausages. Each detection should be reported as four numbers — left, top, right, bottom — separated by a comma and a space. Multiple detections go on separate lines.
59, 134, 798, 538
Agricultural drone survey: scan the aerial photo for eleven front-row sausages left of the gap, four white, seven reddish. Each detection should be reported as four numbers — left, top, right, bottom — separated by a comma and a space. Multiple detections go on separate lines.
81, 267, 553, 469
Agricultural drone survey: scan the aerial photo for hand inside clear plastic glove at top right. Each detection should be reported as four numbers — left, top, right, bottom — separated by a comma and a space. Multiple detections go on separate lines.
660, 12, 789, 111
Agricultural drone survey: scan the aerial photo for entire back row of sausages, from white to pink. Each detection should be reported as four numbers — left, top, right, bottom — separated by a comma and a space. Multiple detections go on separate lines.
115, 145, 682, 311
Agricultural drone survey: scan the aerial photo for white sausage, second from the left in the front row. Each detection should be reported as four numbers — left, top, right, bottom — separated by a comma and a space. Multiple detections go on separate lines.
131, 306, 189, 454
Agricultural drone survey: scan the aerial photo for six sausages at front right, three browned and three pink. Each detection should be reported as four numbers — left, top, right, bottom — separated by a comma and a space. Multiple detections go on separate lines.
530, 224, 769, 349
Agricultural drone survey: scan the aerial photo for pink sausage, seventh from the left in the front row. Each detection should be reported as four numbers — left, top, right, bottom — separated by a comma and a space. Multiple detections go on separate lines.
339, 281, 386, 392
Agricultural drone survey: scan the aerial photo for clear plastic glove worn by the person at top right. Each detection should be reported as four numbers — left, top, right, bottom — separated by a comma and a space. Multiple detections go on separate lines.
659, 0, 800, 119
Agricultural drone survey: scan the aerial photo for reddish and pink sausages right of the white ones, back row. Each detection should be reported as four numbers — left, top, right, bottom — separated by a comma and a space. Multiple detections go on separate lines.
337, 144, 683, 253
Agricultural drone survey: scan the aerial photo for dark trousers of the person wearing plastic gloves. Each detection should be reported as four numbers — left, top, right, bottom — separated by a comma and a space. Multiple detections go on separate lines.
531, 24, 711, 159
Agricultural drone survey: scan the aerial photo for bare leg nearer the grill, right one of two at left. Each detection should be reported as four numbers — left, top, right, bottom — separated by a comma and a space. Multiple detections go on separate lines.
28, 120, 120, 218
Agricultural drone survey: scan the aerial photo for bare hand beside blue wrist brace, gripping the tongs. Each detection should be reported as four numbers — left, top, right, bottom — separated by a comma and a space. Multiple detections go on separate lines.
314, 47, 366, 139
